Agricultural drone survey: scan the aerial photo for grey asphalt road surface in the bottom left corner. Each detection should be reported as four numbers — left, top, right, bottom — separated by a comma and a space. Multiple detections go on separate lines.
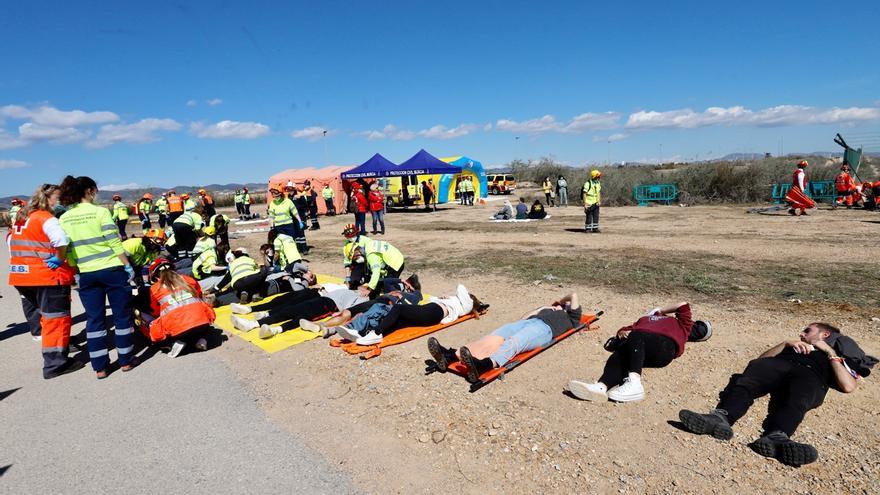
0, 254, 355, 494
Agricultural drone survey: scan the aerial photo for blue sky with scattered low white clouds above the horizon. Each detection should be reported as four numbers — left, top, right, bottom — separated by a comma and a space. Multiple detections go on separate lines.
0, 1, 880, 195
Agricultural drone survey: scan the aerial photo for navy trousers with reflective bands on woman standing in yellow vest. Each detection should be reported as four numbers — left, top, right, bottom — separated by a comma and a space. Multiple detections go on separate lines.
79, 266, 134, 371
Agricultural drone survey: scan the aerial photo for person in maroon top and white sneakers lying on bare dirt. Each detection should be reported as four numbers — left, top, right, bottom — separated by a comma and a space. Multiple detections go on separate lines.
567, 302, 712, 402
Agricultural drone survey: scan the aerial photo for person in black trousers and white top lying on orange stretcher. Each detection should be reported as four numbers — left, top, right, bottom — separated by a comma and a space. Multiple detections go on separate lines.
328, 284, 486, 345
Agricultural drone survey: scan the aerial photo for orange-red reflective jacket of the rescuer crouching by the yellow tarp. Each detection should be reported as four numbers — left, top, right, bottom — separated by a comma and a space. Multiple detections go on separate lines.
149, 275, 215, 342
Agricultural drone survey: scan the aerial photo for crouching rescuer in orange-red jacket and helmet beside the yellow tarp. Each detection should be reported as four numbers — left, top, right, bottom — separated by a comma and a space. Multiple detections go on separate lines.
142, 258, 214, 357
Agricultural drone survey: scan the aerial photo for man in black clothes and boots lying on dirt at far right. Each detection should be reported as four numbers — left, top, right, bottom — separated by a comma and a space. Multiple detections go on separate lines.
678, 323, 877, 466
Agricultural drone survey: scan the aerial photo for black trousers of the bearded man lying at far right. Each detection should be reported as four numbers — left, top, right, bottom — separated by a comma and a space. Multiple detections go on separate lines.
717, 357, 828, 436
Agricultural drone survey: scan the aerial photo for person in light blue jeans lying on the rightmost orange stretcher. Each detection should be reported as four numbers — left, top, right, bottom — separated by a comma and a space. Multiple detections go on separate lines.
428, 292, 582, 383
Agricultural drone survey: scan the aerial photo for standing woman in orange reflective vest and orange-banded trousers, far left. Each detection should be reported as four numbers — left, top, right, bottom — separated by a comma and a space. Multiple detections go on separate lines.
7, 184, 83, 379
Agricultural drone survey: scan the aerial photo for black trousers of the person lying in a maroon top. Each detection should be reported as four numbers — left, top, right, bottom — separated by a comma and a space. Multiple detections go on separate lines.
599, 331, 678, 388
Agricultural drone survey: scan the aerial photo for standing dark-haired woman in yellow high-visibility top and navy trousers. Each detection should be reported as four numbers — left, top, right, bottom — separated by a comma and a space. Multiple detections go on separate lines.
60, 175, 138, 379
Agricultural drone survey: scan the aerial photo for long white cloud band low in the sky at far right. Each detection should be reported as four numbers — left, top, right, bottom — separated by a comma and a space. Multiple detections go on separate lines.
625, 105, 880, 129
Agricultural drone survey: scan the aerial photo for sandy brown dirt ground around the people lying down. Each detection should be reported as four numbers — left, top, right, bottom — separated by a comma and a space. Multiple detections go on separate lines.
210, 196, 880, 493
